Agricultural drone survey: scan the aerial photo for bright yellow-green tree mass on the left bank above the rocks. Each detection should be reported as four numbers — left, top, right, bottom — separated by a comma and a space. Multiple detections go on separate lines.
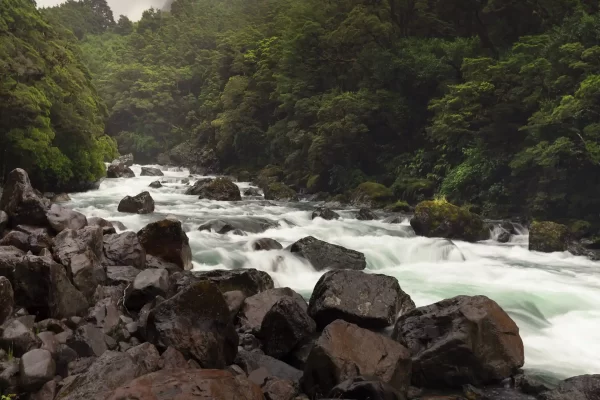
0, 0, 116, 190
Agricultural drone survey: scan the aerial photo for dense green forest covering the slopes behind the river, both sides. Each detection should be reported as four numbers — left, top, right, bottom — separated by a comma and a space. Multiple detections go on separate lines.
0, 0, 600, 229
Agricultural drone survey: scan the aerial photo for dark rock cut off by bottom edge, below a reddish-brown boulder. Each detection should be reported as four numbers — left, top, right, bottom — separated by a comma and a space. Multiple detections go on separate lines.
328, 376, 406, 400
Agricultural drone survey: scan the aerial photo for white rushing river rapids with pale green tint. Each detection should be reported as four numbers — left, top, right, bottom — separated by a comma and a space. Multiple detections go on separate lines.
71, 165, 600, 377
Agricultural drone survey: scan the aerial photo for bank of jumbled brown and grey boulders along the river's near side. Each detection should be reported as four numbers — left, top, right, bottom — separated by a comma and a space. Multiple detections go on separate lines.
0, 170, 600, 400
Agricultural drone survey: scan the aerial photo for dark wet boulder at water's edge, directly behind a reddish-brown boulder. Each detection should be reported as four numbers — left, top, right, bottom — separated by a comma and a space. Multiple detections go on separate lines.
308, 270, 415, 330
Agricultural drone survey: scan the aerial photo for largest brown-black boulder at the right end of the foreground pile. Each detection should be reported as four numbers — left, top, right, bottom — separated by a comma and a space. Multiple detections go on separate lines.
392, 296, 524, 388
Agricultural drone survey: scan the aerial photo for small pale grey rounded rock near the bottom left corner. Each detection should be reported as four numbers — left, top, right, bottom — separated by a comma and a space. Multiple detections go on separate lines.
19, 349, 56, 392
